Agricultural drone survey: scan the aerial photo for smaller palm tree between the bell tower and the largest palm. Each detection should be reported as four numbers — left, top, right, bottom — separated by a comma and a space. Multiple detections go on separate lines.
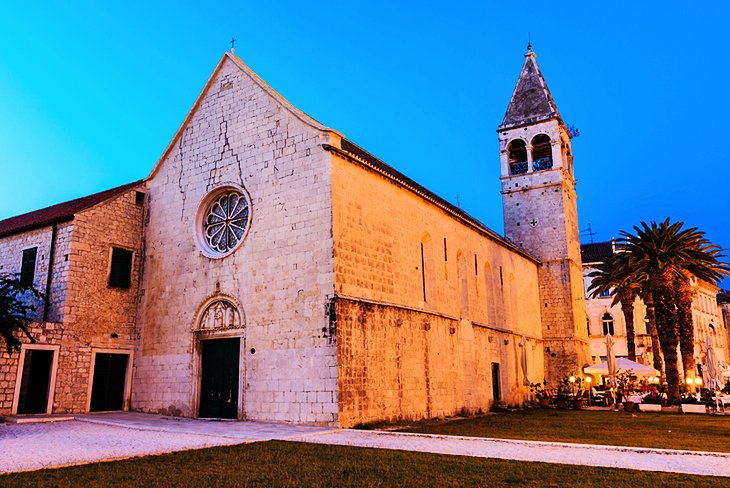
588, 253, 641, 361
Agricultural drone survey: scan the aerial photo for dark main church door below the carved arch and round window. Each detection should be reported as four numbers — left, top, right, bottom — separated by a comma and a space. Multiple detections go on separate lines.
198, 338, 241, 419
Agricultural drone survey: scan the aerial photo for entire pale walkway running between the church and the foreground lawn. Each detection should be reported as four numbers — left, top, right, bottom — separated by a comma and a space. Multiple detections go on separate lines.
0, 412, 730, 477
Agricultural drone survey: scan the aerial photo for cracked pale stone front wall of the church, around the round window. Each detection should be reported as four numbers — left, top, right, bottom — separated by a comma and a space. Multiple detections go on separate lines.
132, 58, 337, 423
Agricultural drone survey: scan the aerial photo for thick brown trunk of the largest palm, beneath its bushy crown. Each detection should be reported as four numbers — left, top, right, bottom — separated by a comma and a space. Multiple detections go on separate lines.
650, 272, 681, 403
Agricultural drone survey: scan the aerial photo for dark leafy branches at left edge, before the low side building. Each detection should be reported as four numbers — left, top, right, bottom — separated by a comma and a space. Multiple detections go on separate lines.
0, 275, 45, 354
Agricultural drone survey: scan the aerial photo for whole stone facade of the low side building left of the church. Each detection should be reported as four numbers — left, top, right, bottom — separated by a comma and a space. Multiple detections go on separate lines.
0, 187, 142, 414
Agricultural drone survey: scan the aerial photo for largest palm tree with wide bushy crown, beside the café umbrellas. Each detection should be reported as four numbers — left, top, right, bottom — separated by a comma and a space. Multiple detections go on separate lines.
619, 218, 730, 402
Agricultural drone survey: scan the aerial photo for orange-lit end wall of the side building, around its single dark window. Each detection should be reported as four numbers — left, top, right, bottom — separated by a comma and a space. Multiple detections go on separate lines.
54, 187, 144, 413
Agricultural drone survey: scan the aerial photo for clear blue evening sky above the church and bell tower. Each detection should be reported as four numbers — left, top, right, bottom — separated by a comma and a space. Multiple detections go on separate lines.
0, 0, 730, 287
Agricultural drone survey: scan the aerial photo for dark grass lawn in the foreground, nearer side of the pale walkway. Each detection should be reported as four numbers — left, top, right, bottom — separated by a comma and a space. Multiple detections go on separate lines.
0, 441, 730, 488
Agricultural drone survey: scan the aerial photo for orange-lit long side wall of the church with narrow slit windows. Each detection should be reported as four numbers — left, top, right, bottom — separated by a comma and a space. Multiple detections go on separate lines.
332, 152, 543, 427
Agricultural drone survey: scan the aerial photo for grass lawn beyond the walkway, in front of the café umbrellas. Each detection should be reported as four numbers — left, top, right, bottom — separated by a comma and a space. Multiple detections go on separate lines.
390, 410, 730, 452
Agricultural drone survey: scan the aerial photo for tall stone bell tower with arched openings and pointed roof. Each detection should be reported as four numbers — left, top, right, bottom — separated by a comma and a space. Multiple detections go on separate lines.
497, 46, 590, 385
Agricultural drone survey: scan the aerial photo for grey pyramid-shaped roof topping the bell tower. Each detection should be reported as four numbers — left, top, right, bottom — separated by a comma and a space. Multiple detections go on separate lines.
499, 52, 560, 129
